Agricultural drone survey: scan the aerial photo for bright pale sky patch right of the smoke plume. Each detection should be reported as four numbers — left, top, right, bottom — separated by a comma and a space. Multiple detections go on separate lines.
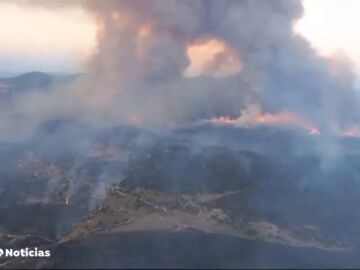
294, 0, 360, 74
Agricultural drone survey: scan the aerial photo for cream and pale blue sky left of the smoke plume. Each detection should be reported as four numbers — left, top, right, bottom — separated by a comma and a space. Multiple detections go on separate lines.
0, 0, 96, 74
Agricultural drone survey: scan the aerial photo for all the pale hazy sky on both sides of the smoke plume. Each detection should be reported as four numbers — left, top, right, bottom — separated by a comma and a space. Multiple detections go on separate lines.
0, 0, 360, 74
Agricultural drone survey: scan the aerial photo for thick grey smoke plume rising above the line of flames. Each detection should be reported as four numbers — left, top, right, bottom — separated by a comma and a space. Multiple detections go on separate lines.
1, 0, 359, 140
